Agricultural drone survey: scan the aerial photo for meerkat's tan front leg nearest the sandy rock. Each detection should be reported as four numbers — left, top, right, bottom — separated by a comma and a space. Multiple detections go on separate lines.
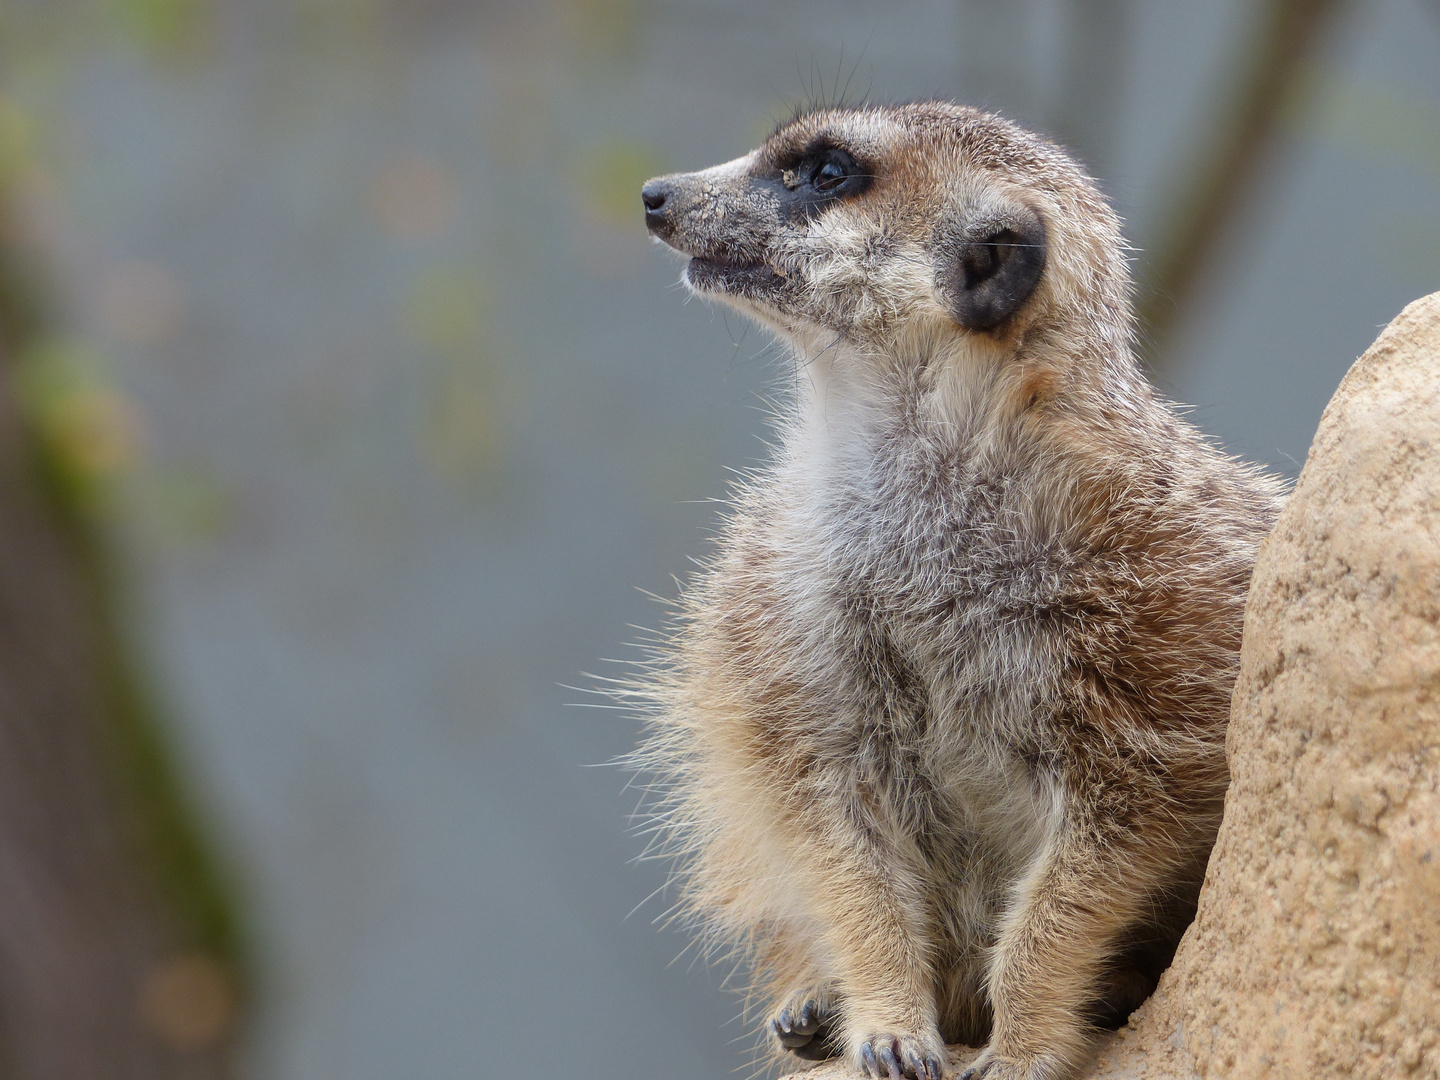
960, 822, 1172, 1080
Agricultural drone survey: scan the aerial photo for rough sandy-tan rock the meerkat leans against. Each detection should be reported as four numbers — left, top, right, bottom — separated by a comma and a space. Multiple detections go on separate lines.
805, 292, 1440, 1080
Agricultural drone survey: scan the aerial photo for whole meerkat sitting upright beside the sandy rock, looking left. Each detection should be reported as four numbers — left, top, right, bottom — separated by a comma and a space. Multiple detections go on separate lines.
635, 102, 1283, 1080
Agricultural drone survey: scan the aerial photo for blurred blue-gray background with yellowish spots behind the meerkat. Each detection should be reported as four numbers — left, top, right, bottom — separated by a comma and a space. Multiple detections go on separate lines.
0, 0, 1440, 1080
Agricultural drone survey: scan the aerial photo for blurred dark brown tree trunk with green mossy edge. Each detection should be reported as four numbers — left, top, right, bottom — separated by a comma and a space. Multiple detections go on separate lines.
0, 146, 238, 1080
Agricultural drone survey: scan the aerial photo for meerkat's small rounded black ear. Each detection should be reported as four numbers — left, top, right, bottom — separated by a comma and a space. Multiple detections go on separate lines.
935, 206, 1045, 330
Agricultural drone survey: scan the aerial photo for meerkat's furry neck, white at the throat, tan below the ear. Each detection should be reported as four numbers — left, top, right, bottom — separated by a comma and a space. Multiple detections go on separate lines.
778, 324, 1161, 541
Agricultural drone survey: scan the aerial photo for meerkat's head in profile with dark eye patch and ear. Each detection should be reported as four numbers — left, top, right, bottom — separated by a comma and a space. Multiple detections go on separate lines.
642, 102, 1129, 368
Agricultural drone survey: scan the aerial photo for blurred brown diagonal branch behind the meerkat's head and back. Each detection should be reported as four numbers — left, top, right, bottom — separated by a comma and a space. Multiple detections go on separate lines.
1139, 0, 1342, 367
